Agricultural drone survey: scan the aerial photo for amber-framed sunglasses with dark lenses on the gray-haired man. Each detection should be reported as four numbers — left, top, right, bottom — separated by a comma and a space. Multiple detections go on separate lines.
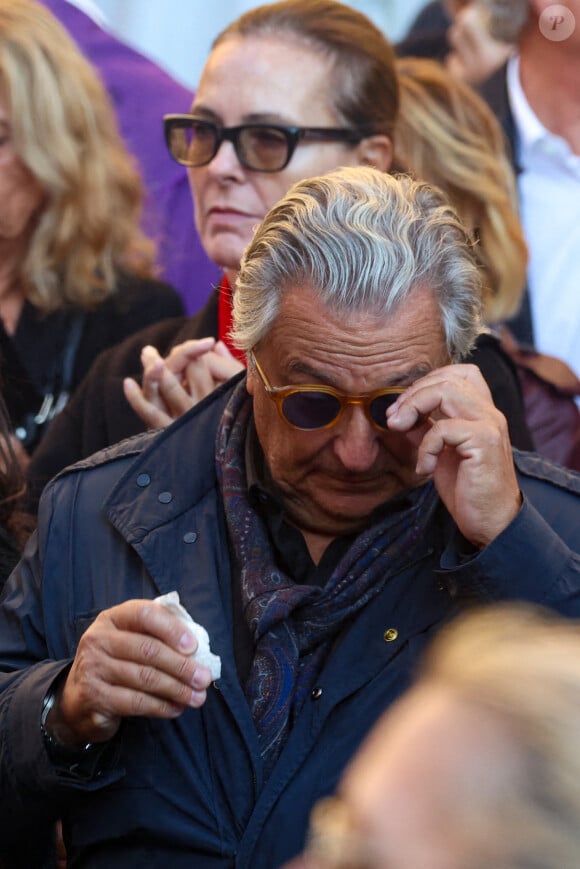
249, 351, 405, 431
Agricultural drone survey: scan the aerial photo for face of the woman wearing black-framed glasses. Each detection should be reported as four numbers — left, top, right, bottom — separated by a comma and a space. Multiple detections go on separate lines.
188, 37, 380, 271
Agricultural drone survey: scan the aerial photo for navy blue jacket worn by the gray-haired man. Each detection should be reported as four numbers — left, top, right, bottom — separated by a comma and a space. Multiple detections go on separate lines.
0, 376, 580, 869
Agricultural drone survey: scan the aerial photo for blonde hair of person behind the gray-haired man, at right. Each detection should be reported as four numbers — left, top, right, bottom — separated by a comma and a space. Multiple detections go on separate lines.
395, 58, 527, 322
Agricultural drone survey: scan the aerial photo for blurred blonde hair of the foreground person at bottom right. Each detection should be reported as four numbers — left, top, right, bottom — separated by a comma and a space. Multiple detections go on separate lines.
418, 603, 580, 869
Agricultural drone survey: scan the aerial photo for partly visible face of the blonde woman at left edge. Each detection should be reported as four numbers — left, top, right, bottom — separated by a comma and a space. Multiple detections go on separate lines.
0, 97, 43, 242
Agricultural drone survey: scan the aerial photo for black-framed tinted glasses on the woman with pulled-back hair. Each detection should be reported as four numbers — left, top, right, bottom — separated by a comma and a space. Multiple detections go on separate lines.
163, 115, 369, 172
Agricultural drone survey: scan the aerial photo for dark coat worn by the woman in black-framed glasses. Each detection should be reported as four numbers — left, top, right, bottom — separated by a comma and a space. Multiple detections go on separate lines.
28, 290, 533, 513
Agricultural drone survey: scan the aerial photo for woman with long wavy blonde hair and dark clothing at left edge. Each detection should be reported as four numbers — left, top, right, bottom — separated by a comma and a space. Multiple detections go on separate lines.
0, 0, 183, 453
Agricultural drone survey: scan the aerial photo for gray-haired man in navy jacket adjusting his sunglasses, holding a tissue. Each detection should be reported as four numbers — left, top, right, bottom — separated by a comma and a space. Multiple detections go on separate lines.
0, 168, 580, 869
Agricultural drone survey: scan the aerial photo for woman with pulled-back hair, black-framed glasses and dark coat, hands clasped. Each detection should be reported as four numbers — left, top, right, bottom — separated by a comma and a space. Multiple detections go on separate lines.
24, 0, 531, 509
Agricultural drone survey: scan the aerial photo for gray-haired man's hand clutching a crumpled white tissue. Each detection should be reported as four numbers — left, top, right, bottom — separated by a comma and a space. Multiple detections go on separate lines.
46, 600, 211, 749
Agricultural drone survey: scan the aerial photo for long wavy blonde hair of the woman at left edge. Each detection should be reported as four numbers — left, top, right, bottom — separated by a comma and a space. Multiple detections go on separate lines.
0, 0, 155, 311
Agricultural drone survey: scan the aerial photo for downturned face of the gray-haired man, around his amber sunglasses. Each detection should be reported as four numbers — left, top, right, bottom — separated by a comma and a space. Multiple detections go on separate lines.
248, 286, 449, 538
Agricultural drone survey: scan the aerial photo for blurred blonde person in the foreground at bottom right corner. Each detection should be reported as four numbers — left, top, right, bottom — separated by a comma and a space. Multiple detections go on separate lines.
294, 603, 580, 869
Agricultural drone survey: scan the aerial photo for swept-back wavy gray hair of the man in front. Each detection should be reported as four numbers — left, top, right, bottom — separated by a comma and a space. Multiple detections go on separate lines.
233, 167, 482, 360
